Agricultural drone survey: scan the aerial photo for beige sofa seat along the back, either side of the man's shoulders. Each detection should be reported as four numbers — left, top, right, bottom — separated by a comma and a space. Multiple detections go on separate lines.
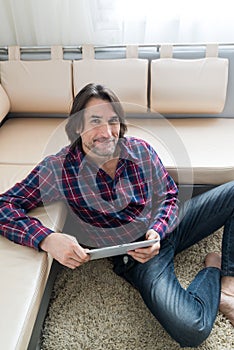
0, 115, 234, 186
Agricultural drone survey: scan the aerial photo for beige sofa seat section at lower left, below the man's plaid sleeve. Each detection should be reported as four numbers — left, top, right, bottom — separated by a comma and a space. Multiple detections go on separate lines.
0, 203, 65, 350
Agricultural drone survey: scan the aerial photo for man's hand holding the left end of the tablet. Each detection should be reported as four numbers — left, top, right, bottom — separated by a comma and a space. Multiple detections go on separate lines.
40, 232, 90, 269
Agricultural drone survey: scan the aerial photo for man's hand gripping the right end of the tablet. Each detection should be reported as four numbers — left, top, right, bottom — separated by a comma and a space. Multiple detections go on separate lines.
128, 229, 160, 263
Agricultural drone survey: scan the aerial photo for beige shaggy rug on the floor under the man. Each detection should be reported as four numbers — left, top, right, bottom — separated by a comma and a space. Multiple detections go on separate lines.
41, 232, 234, 350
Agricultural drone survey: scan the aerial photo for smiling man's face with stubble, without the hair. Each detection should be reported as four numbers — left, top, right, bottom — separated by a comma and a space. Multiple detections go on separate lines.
81, 98, 120, 158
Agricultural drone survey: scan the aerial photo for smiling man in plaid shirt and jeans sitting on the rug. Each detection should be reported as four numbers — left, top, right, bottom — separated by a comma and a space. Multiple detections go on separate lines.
0, 84, 234, 347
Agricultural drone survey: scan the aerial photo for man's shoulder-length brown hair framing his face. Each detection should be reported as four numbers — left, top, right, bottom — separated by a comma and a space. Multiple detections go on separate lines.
65, 83, 127, 144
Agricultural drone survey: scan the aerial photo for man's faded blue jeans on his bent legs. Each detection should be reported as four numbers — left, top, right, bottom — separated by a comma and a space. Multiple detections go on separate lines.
113, 181, 234, 347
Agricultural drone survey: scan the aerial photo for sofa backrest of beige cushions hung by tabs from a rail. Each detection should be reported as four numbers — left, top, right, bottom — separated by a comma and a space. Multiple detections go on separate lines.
0, 45, 234, 118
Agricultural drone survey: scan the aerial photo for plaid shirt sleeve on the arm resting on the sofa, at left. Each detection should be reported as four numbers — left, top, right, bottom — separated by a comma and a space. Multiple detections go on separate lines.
0, 157, 61, 250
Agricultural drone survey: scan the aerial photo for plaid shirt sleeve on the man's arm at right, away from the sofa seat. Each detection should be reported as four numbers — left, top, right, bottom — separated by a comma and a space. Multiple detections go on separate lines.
150, 144, 178, 239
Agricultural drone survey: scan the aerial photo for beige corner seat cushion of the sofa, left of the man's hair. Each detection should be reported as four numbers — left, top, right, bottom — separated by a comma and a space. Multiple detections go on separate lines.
0, 118, 69, 165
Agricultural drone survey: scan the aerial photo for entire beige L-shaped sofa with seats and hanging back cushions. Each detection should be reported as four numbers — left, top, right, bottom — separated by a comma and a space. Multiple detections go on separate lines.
0, 45, 234, 350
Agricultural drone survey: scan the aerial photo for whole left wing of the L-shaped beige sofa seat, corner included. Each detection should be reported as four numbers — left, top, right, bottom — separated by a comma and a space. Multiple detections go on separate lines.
0, 118, 67, 350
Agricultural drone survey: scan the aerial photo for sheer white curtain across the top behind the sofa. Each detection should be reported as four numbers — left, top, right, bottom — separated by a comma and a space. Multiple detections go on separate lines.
0, 0, 234, 46
